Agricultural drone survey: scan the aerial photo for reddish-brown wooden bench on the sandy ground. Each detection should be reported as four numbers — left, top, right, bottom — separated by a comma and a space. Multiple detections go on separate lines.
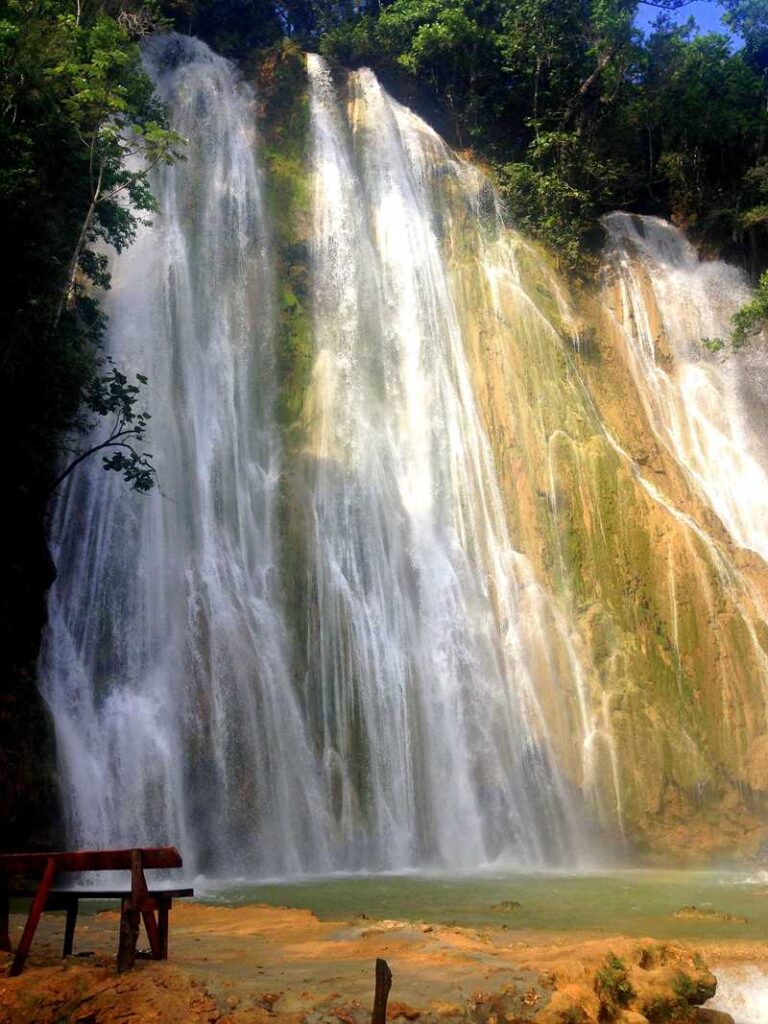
0, 846, 195, 977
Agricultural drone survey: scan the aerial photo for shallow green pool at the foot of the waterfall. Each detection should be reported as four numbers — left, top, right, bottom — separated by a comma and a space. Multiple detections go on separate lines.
197, 870, 768, 940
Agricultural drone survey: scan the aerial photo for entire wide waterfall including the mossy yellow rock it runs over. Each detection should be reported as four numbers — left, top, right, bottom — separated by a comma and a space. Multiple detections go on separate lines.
40, 28, 768, 878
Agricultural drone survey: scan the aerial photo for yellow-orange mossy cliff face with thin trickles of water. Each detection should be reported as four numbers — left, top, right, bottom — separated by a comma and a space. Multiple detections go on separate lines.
448, 211, 768, 860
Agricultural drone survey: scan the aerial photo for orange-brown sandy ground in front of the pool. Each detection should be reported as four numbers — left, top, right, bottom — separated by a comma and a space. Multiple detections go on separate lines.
0, 903, 768, 1024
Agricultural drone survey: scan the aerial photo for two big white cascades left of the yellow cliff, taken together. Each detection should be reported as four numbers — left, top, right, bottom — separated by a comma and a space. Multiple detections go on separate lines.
42, 37, 588, 876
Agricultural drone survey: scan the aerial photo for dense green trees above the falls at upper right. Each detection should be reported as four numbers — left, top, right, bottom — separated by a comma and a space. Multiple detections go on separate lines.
319, 0, 768, 270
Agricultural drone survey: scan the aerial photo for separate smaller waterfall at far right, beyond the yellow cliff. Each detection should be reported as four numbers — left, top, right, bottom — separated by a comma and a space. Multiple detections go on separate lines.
604, 213, 768, 560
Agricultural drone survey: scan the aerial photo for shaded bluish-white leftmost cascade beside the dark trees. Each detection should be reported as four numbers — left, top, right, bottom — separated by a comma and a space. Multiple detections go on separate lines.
42, 37, 328, 873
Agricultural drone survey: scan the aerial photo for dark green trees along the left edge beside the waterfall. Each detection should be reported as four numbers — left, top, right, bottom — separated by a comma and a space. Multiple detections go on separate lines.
0, 0, 181, 674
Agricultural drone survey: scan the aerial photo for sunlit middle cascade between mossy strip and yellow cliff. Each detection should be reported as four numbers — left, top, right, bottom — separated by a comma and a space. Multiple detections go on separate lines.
296, 56, 575, 867
